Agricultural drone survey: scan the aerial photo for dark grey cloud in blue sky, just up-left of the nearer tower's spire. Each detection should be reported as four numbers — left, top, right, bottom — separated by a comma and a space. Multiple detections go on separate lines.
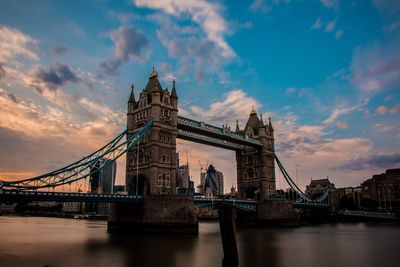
100, 27, 150, 74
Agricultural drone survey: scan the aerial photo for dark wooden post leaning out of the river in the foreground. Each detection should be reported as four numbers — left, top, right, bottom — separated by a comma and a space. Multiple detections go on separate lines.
218, 205, 239, 267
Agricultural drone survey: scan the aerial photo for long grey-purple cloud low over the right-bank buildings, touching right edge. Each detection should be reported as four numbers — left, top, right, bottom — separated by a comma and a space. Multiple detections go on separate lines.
338, 154, 400, 171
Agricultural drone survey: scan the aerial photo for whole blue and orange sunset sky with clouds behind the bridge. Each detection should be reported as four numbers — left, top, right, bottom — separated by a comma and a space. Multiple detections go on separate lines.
0, 0, 400, 192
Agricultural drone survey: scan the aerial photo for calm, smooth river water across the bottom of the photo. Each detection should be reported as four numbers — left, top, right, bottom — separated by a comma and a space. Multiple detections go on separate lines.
0, 216, 400, 267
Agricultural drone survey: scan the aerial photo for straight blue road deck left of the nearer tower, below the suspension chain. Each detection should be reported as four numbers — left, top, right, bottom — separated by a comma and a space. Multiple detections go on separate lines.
0, 190, 143, 203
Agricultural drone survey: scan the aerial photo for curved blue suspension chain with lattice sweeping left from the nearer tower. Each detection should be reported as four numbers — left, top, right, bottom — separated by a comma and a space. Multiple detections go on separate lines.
0, 120, 153, 190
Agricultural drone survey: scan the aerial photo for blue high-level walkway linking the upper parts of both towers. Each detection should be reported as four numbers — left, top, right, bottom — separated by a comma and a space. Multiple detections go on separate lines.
177, 116, 263, 151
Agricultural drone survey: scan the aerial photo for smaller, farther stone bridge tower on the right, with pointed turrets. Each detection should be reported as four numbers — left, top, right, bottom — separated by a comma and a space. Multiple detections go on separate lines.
236, 108, 275, 200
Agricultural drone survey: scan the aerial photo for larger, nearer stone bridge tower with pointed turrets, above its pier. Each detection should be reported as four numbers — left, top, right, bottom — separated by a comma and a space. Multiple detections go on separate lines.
125, 68, 178, 195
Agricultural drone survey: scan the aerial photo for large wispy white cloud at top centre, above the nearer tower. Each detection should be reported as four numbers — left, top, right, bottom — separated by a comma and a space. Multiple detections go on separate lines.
133, 0, 238, 83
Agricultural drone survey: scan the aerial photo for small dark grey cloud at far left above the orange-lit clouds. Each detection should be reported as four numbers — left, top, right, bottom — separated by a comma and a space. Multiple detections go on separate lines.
34, 63, 78, 90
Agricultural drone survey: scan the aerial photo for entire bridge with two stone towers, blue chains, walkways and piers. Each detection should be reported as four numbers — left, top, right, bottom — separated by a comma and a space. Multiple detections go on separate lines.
0, 69, 329, 231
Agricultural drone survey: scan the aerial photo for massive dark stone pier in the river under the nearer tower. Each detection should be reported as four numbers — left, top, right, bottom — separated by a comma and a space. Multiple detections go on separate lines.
108, 195, 198, 233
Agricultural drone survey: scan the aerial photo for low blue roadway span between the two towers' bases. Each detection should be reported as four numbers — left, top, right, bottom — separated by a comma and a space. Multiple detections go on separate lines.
194, 198, 258, 212
